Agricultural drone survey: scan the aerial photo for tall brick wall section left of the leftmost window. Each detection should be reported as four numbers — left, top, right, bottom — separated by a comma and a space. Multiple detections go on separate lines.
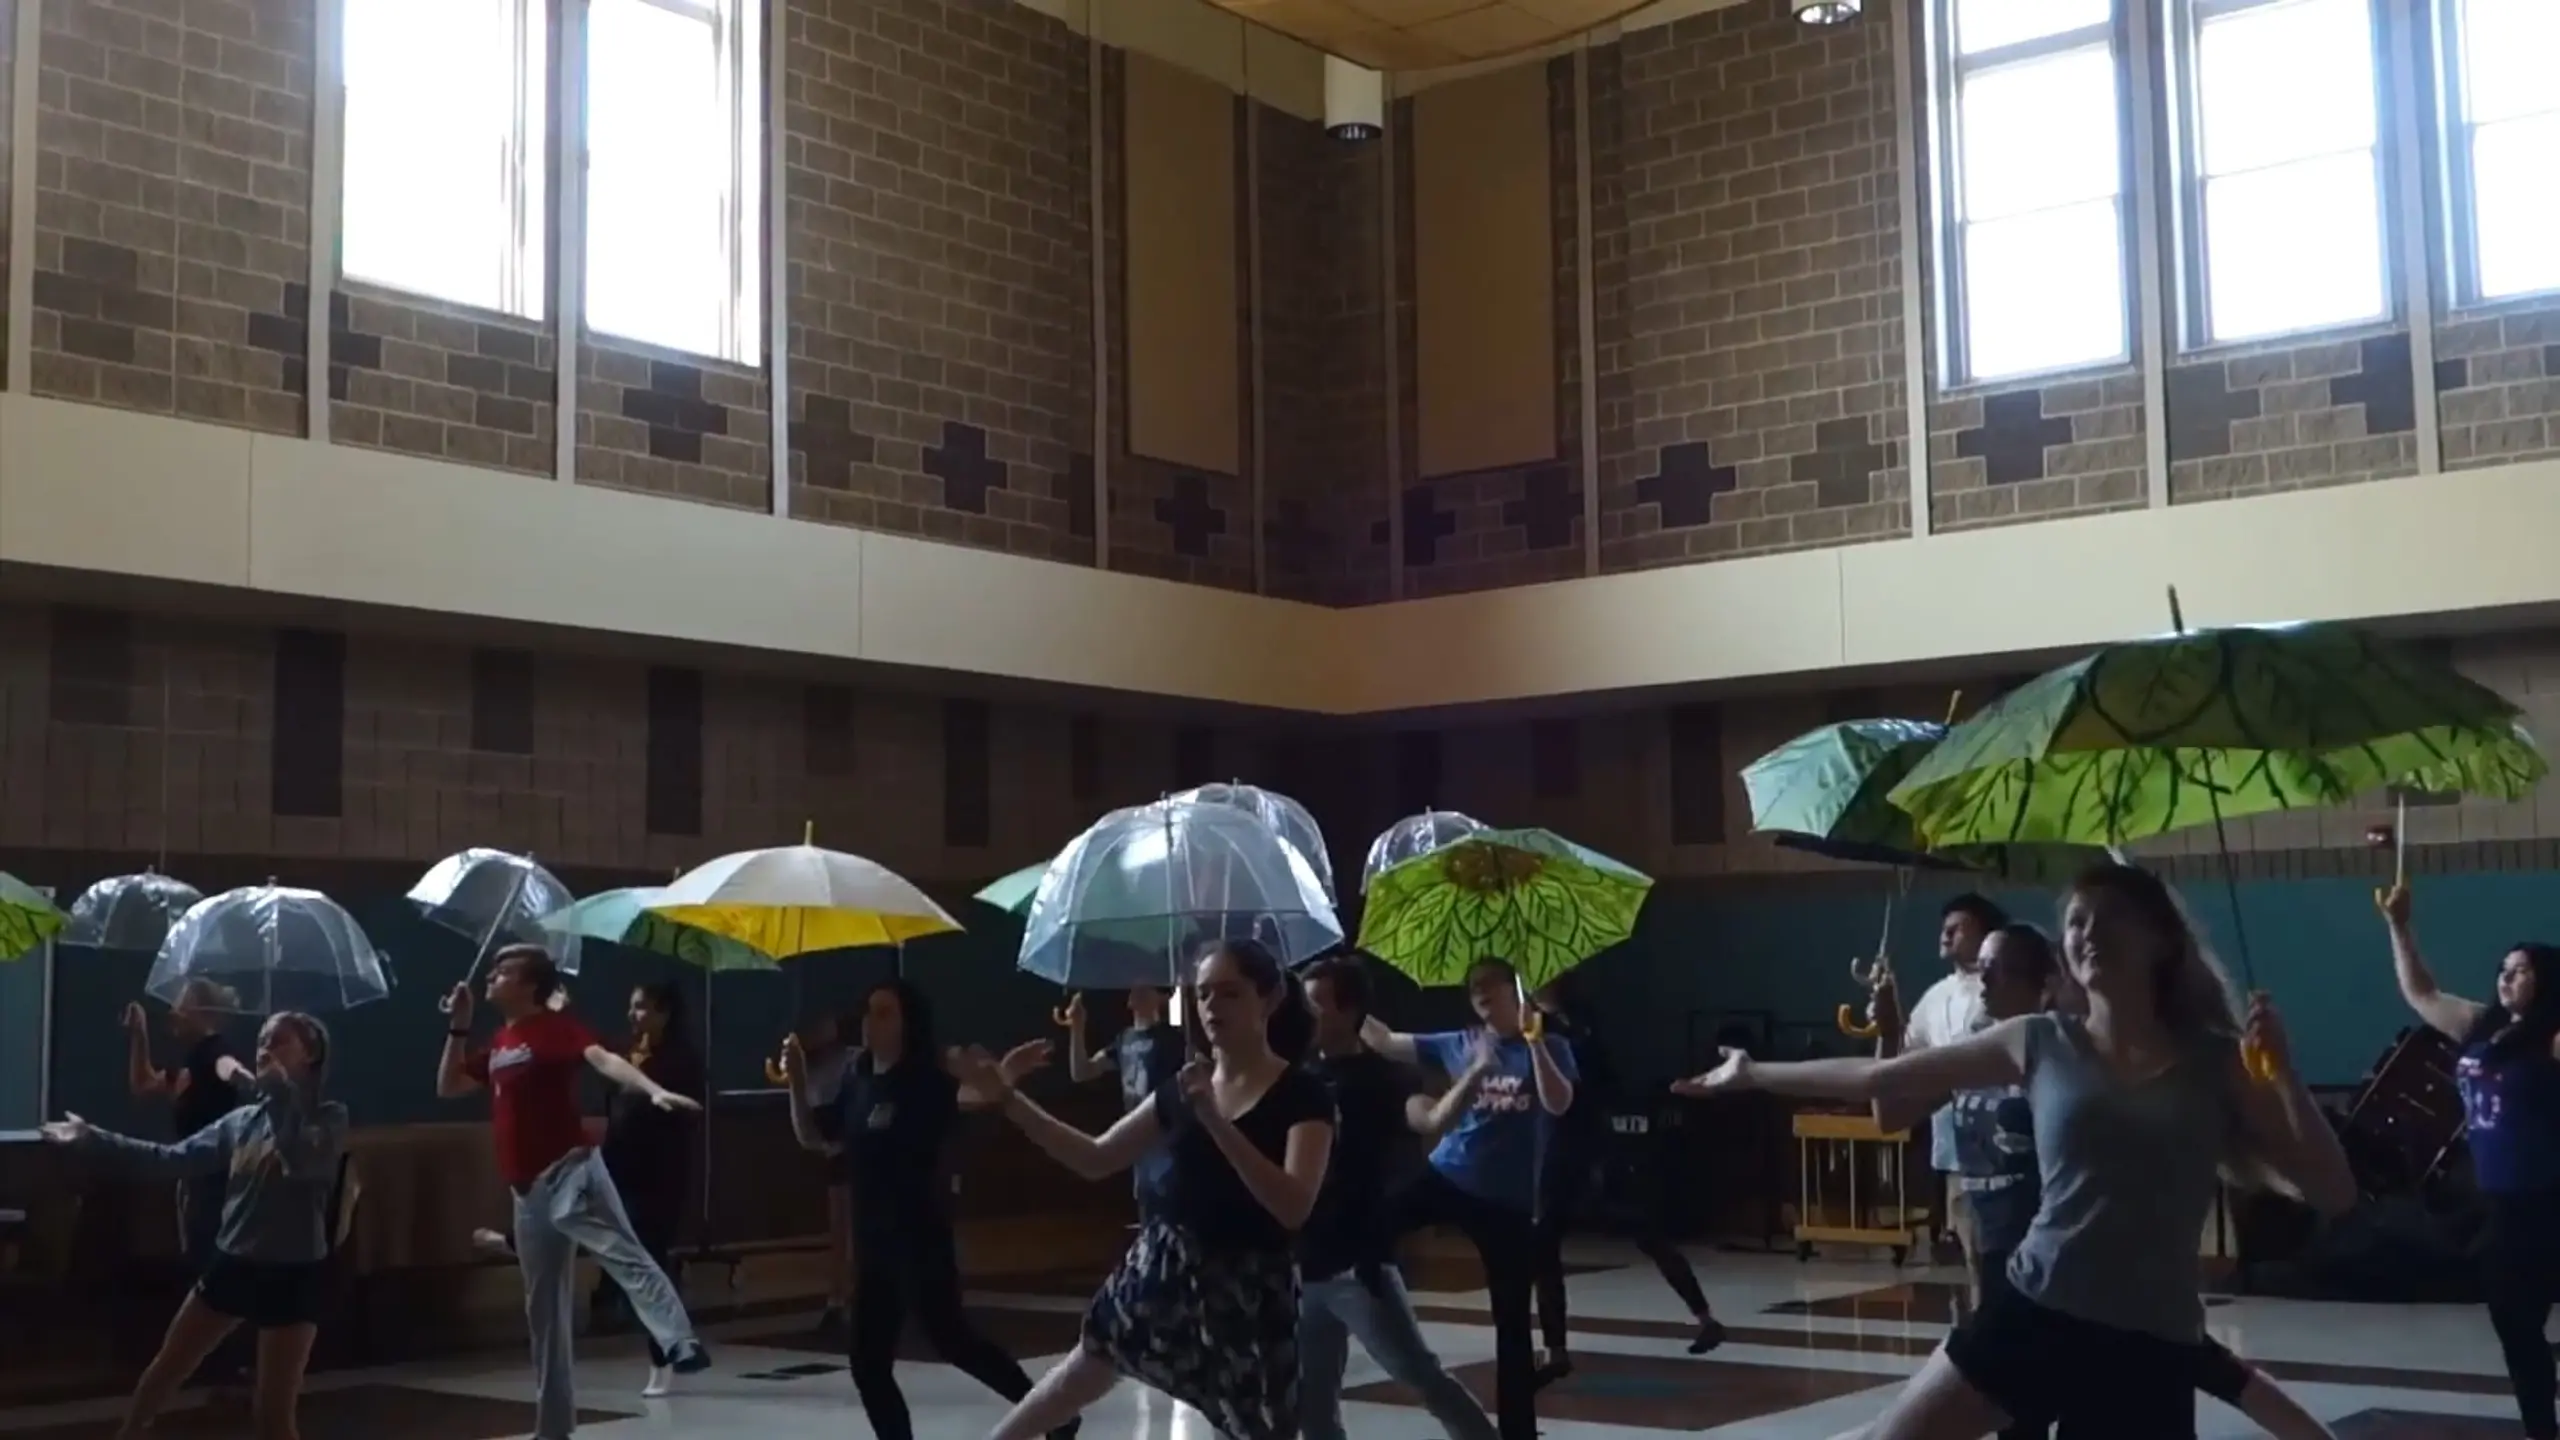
28, 0, 312, 436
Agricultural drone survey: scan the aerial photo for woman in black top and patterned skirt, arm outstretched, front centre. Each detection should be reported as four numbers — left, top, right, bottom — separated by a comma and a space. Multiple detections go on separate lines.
963, 940, 1334, 1440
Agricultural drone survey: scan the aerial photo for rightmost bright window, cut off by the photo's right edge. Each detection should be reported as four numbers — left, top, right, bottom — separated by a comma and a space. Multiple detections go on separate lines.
2450, 0, 2560, 300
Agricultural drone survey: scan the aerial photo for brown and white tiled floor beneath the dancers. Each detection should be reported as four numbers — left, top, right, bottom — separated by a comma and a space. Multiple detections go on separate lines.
0, 1245, 2519, 1440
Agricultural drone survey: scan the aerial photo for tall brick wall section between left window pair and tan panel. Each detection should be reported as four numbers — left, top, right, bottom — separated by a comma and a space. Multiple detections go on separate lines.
783, 0, 1093, 564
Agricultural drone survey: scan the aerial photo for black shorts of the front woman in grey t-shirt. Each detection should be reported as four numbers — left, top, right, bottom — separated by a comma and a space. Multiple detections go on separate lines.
1946, 1284, 2202, 1440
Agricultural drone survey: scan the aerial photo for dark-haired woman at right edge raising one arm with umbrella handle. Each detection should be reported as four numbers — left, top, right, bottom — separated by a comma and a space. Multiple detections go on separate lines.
2381, 887, 2560, 1440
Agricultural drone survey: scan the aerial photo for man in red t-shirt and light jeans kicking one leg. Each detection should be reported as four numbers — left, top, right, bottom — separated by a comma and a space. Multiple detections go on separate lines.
435, 945, 712, 1440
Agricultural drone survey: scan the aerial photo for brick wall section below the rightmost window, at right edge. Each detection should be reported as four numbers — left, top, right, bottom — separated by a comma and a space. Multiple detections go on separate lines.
2435, 300, 2560, 469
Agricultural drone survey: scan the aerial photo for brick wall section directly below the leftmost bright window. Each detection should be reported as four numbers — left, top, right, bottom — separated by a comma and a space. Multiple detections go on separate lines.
327, 282, 558, 477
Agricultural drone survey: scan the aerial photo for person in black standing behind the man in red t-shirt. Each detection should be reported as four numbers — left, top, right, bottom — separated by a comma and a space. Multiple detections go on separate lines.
596, 984, 709, 1399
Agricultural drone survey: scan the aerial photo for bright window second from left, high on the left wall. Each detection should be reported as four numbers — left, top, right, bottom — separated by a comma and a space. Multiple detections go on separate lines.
586, 0, 763, 364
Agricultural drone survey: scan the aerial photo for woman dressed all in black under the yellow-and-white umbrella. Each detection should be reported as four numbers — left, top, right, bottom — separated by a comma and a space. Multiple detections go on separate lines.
783, 979, 1075, 1440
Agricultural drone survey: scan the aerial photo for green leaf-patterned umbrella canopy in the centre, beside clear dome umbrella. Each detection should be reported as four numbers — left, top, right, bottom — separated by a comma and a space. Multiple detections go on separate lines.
1359, 830, 1654, 989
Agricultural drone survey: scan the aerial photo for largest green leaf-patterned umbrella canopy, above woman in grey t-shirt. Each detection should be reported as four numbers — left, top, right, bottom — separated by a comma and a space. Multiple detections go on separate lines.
1889, 625, 2550, 848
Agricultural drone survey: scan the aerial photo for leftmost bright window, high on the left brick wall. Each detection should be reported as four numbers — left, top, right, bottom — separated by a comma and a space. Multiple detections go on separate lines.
338, 0, 548, 318
